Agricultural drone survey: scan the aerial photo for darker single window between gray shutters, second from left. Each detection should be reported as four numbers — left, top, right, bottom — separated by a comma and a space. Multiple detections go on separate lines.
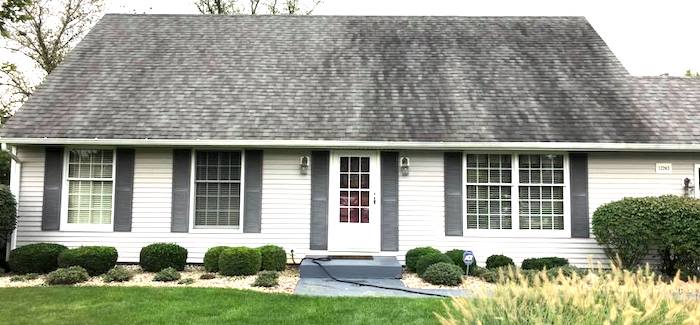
194, 151, 241, 228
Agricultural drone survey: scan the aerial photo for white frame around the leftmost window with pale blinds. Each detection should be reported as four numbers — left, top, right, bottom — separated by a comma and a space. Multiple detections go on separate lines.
60, 146, 117, 232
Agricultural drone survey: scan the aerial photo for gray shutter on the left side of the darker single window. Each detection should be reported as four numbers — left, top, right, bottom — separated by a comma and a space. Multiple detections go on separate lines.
170, 149, 192, 232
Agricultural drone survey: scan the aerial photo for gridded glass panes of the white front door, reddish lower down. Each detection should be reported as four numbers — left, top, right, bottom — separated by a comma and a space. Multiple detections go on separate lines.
339, 156, 370, 223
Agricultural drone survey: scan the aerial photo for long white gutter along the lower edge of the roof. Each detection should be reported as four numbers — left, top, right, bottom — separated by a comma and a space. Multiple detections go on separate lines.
0, 138, 700, 152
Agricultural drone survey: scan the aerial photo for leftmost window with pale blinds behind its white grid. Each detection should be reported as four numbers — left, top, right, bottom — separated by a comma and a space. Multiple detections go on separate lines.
67, 149, 114, 224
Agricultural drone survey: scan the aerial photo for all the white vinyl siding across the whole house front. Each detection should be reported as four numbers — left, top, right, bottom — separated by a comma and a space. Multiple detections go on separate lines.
16, 146, 700, 266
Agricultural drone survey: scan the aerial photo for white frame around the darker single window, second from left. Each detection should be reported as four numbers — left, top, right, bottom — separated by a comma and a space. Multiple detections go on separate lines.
189, 148, 245, 234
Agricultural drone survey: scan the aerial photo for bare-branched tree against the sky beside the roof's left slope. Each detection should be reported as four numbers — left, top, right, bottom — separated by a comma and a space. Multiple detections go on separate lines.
0, 0, 103, 117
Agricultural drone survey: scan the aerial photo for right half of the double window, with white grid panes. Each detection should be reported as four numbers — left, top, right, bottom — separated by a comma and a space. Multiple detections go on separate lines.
518, 155, 564, 230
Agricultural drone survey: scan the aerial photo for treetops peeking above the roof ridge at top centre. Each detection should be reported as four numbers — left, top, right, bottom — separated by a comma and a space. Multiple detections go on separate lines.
195, 0, 321, 15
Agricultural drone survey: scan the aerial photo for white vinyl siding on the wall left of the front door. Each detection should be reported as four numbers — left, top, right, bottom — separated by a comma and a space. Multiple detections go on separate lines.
16, 147, 311, 263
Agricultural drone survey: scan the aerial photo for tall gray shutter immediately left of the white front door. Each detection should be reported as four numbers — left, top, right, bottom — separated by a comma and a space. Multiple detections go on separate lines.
310, 151, 330, 250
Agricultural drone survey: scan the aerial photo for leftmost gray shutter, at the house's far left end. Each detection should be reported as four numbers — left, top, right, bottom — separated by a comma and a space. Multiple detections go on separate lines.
41, 147, 63, 230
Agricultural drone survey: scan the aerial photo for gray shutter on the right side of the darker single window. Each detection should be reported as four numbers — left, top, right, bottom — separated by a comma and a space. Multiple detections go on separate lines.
243, 150, 263, 233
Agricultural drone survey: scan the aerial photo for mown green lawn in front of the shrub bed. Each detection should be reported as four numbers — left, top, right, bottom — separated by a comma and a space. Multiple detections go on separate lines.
0, 287, 443, 325
